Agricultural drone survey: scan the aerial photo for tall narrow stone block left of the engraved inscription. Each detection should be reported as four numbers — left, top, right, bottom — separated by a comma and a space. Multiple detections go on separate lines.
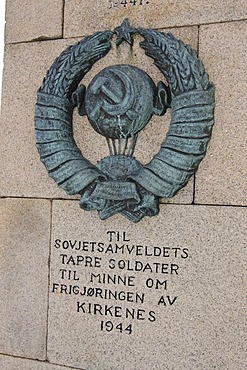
0, 199, 51, 358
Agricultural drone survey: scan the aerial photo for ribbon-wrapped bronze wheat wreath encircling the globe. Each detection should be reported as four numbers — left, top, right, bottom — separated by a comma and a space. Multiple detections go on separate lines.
35, 24, 214, 222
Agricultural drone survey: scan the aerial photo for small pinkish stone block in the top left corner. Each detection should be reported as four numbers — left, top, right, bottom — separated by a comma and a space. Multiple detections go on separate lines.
5, 0, 63, 44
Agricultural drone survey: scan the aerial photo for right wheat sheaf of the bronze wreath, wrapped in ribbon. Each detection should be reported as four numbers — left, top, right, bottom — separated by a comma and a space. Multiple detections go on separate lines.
131, 29, 214, 197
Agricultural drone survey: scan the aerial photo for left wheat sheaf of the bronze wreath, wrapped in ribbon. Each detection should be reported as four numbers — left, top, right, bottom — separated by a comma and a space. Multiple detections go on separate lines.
35, 31, 112, 194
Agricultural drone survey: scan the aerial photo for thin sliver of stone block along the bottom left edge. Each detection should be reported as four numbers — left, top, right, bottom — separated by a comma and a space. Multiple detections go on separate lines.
0, 355, 79, 370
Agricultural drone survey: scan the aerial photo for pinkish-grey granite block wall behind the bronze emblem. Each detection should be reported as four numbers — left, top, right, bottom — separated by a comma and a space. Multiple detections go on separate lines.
0, 0, 247, 370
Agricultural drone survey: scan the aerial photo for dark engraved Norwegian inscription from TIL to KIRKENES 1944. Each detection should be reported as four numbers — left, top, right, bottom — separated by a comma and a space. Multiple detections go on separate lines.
51, 230, 189, 334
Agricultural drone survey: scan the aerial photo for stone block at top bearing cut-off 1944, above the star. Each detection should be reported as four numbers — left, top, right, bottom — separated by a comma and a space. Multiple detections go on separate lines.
64, 0, 247, 37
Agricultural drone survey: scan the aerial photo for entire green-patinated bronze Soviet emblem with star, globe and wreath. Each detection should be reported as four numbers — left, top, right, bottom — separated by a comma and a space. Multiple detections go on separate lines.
35, 20, 214, 222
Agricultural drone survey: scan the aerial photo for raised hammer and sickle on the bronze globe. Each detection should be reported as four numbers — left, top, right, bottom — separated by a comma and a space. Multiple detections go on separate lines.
91, 69, 136, 120
